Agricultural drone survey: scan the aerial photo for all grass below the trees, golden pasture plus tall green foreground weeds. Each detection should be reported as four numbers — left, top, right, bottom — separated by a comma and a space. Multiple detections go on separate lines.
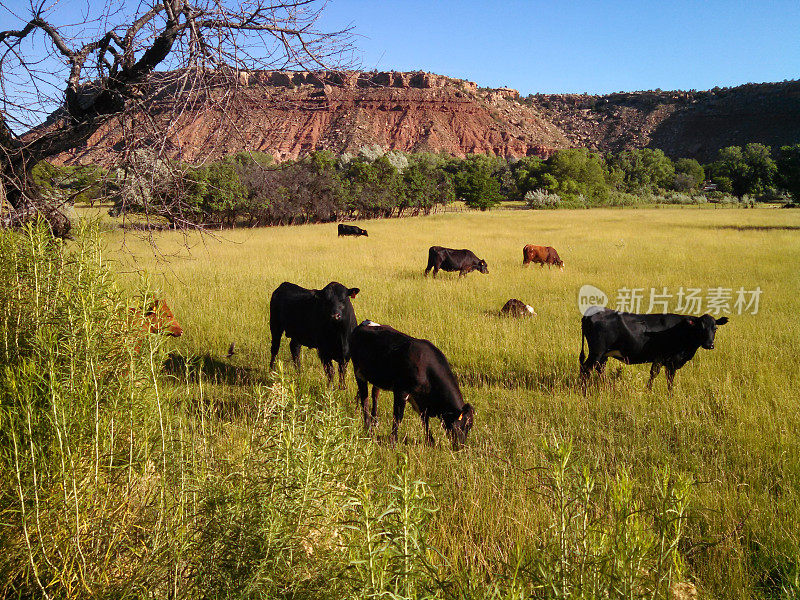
6, 209, 800, 598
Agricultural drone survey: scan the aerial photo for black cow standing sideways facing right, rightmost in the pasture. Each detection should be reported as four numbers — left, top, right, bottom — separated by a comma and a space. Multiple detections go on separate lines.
580, 308, 728, 392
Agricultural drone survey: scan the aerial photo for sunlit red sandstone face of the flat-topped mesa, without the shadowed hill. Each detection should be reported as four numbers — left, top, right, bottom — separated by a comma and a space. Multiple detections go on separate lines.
60, 71, 569, 163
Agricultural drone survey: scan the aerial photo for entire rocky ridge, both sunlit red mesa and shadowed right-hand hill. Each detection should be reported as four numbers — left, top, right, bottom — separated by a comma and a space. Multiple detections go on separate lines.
53, 71, 800, 163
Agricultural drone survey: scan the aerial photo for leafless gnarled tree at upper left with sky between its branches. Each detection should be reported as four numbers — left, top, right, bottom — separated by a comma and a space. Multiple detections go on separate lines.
0, 0, 352, 236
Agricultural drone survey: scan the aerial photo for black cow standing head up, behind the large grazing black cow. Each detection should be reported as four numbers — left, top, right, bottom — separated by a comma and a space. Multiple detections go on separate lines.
269, 281, 359, 389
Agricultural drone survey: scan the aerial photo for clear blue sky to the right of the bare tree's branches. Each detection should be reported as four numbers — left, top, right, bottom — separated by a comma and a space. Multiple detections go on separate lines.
323, 0, 800, 95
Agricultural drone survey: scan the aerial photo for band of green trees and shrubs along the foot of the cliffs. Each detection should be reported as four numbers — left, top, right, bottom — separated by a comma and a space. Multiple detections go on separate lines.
28, 143, 800, 227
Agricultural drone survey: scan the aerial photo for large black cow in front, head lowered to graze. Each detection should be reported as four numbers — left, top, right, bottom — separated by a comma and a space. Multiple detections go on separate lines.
352, 321, 475, 448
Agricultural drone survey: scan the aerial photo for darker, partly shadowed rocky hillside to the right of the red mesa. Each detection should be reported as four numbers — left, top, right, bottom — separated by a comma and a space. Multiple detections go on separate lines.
524, 81, 800, 161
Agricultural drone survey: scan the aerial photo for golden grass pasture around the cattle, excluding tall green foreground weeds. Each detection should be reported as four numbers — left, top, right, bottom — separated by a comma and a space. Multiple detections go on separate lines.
104, 207, 800, 598
